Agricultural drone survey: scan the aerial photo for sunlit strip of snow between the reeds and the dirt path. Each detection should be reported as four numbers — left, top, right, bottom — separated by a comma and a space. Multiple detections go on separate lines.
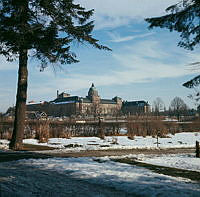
0, 132, 200, 151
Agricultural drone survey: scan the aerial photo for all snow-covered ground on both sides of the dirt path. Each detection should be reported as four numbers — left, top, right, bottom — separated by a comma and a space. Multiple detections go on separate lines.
0, 133, 200, 197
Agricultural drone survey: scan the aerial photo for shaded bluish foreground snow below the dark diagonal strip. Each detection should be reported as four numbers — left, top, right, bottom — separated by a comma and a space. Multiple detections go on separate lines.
0, 157, 200, 197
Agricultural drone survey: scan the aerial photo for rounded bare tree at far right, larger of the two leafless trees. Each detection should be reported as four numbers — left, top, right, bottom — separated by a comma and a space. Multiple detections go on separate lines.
170, 97, 188, 120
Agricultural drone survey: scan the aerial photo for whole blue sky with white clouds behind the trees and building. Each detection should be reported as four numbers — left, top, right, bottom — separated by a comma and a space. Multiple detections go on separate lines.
0, 0, 199, 112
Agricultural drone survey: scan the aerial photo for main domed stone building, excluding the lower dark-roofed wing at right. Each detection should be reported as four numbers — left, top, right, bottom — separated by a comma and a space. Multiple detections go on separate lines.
27, 84, 122, 116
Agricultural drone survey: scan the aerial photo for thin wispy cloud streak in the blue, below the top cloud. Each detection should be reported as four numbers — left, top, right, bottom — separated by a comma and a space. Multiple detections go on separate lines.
108, 32, 153, 42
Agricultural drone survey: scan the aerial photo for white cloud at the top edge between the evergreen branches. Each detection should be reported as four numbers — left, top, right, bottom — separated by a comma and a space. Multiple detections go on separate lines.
77, 0, 178, 29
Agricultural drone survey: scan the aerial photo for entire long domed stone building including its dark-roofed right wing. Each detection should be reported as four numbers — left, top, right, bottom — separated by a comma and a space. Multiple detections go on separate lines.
27, 84, 150, 117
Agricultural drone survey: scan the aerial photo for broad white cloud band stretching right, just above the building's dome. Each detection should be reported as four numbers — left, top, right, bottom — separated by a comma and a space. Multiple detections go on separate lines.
28, 41, 196, 97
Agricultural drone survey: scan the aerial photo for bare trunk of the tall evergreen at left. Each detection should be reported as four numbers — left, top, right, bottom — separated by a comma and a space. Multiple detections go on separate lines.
9, 49, 28, 150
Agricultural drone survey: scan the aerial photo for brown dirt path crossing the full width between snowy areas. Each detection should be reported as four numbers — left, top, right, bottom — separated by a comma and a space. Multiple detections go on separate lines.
0, 145, 195, 162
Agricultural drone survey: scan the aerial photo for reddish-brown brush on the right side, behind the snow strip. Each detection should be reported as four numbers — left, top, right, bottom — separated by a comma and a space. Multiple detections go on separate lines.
127, 115, 200, 139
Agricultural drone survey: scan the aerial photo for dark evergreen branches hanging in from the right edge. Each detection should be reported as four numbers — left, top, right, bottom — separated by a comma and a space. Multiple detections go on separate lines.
145, 0, 200, 101
